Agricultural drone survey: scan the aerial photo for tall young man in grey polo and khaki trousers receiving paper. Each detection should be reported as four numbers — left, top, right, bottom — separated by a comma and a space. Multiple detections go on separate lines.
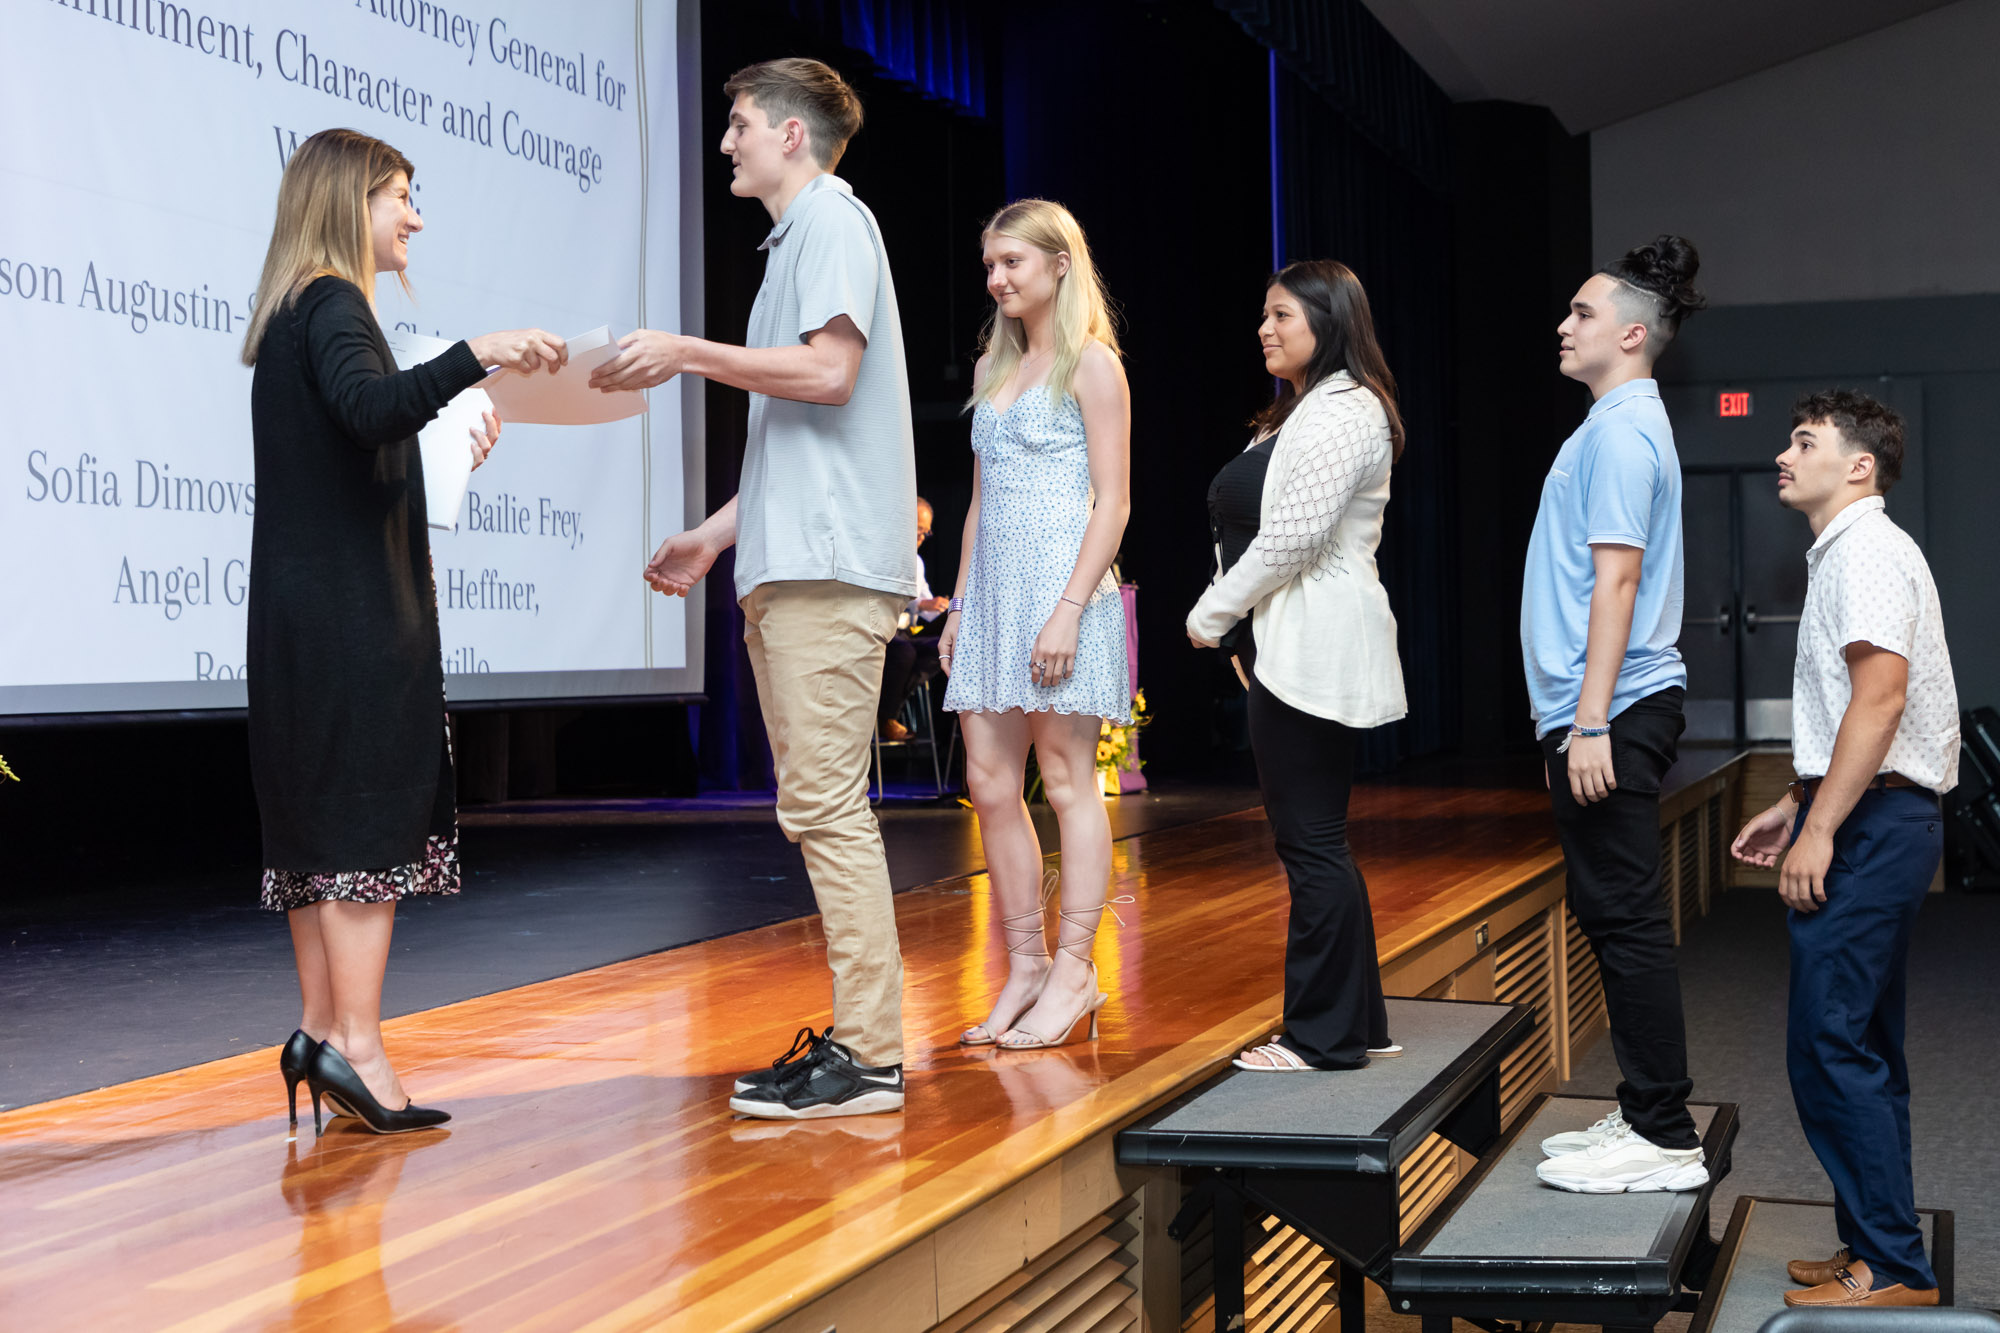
592, 60, 916, 1119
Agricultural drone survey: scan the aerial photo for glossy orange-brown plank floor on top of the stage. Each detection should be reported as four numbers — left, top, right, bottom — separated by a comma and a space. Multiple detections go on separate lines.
0, 787, 1558, 1333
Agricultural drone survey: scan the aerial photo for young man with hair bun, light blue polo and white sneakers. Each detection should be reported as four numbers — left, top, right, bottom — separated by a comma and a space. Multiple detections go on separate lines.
1520, 236, 1708, 1195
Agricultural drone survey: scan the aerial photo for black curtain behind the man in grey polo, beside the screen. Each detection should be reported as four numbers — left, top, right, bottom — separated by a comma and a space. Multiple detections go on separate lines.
690, 0, 1004, 791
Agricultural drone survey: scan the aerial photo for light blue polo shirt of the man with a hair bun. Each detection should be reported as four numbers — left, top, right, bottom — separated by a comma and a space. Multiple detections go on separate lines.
1520, 380, 1688, 737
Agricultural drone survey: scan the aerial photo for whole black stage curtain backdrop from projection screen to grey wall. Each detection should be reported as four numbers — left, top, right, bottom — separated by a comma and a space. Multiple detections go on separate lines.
698, 0, 1462, 787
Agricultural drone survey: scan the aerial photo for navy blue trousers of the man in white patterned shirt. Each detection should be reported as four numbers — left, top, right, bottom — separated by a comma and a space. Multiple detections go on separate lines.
1786, 787, 1944, 1291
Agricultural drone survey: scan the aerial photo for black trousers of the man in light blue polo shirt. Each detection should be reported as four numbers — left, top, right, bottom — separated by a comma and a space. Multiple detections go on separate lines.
1542, 687, 1700, 1149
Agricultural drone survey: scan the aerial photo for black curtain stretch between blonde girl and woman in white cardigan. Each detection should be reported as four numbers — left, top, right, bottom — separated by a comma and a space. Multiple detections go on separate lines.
992, 0, 1270, 781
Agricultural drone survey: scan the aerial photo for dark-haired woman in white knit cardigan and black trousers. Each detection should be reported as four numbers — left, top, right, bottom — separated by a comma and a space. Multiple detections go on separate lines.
1188, 260, 1406, 1073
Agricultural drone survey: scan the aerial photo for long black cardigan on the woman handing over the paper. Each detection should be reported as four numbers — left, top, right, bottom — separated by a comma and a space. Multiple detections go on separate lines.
246, 278, 484, 871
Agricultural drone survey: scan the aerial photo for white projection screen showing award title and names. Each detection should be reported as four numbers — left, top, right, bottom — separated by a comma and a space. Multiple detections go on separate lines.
0, 0, 702, 715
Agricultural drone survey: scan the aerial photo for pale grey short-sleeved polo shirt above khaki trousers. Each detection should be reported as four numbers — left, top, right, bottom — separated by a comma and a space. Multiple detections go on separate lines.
736, 176, 916, 598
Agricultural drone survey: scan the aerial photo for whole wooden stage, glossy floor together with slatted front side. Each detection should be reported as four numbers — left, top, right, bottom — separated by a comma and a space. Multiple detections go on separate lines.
0, 753, 1742, 1333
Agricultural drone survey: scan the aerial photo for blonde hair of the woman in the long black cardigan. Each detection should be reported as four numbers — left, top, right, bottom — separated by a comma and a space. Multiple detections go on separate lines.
244, 130, 416, 366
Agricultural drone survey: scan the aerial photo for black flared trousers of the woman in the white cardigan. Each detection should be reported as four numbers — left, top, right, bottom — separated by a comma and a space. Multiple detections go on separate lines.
1244, 652, 1390, 1069
